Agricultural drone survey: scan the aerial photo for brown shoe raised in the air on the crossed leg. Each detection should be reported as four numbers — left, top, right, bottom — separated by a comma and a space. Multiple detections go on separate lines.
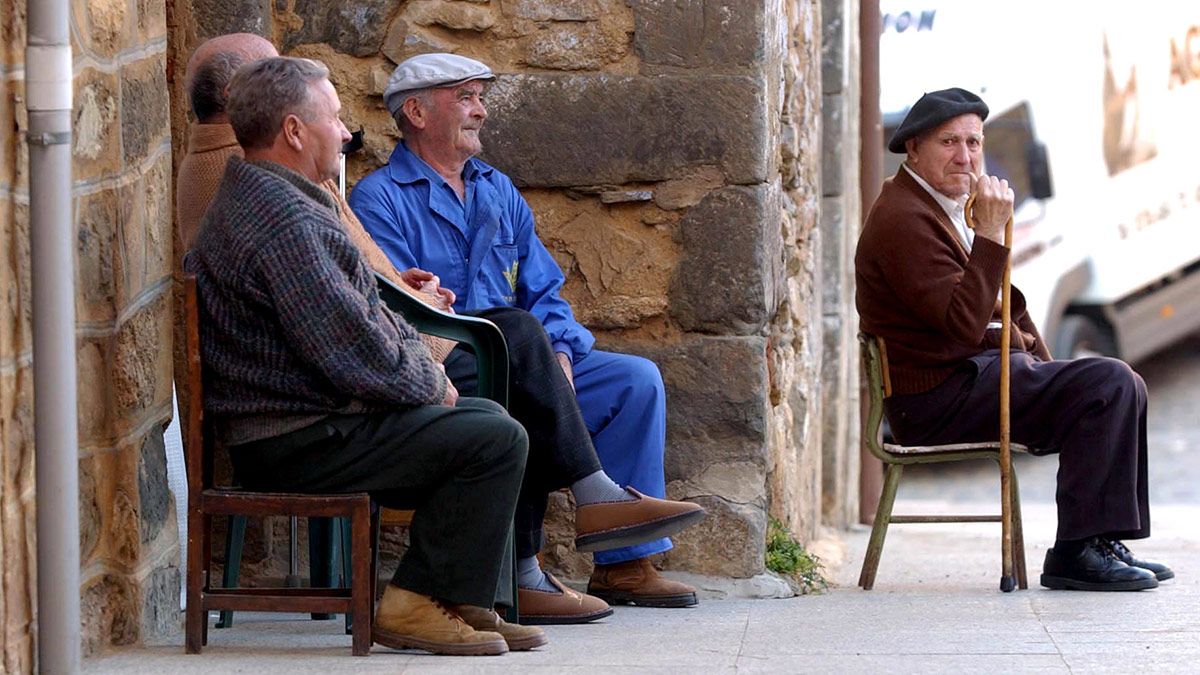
575, 488, 704, 551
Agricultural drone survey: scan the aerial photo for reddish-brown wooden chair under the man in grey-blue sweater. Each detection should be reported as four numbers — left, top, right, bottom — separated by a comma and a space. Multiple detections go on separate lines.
184, 275, 374, 656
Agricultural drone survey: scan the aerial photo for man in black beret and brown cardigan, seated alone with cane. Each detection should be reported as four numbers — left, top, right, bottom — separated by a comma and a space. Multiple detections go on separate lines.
854, 88, 1174, 591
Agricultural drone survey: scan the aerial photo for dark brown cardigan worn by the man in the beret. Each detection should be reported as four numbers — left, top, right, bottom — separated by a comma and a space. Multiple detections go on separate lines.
854, 168, 1050, 394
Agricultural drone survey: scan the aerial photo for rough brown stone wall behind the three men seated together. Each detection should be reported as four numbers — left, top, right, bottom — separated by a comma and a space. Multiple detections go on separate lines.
170, 0, 844, 578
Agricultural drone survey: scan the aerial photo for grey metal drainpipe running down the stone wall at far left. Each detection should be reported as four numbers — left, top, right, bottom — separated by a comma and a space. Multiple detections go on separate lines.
25, 0, 82, 674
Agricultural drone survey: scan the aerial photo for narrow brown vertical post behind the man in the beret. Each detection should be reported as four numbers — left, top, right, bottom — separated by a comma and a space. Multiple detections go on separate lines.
858, 0, 883, 522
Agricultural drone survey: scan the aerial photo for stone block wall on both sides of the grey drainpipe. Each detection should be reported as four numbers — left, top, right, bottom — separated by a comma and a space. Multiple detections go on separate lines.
0, 0, 180, 658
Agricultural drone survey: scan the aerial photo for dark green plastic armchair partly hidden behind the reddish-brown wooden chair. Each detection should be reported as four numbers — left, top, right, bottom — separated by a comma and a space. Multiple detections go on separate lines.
216, 274, 518, 634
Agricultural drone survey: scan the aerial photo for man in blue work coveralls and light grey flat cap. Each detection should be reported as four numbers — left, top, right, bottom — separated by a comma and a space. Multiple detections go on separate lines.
349, 54, 696, 622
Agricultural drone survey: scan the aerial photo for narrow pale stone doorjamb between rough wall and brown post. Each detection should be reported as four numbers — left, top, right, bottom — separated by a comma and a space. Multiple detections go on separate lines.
820, 0, 862, 527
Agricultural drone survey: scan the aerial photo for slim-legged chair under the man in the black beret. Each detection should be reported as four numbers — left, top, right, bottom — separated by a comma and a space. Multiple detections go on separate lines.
858, 333, 1028, 591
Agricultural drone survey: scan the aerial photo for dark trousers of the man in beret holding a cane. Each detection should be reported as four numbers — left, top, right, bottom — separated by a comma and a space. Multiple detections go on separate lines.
884, 350, 1150, 539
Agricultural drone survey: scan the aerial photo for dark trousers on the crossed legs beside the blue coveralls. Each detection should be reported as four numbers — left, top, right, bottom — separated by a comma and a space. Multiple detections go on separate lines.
445, 307, 600, 557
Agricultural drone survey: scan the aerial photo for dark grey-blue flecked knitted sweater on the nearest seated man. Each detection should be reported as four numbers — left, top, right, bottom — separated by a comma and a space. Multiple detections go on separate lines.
185, 157, 445, 444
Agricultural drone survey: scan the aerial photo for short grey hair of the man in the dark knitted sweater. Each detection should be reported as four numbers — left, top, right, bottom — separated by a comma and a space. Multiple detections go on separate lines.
226, 56, 329, 150
